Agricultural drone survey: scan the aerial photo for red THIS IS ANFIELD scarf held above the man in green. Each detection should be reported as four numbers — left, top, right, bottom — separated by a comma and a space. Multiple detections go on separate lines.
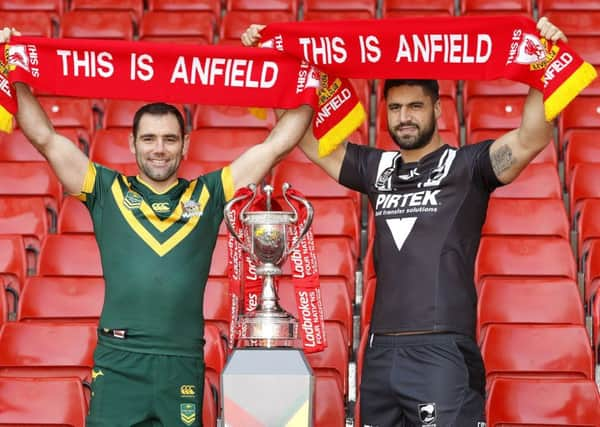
0, 37, 365, 154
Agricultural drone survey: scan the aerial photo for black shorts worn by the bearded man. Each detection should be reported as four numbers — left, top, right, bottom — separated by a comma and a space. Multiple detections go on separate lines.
360, 333, 485, 427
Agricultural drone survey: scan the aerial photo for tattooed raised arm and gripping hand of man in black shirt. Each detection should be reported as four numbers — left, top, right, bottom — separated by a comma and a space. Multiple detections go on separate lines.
490, 17, 567, 184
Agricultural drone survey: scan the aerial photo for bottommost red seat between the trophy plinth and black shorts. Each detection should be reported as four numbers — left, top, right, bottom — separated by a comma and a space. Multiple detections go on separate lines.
313, 374, 346, 427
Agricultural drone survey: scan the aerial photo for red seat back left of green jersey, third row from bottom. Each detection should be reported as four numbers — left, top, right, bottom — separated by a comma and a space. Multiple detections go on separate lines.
18, 276, 104, 323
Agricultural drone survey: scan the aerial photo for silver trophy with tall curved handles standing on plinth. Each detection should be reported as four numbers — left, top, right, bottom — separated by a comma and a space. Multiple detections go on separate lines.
224, 183, 313, 348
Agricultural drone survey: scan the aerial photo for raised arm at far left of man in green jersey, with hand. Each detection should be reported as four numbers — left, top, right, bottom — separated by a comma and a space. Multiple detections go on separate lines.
0, 27, 89, 194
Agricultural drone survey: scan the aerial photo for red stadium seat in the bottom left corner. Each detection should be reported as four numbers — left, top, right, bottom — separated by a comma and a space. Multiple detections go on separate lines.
0, 378, 87, 427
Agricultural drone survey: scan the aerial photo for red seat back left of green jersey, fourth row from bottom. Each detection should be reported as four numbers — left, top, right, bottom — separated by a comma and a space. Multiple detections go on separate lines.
38, 234, 102, 277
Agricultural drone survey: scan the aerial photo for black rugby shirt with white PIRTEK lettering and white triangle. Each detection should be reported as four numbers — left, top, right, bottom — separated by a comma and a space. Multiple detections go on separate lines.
340, 141, 501, 336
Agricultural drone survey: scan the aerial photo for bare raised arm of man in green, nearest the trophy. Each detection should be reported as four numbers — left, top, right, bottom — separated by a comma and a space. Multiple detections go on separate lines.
231, 105, 313, 190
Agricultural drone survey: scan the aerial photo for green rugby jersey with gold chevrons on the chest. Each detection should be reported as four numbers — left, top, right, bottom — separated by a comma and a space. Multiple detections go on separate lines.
78, 162, 233, 357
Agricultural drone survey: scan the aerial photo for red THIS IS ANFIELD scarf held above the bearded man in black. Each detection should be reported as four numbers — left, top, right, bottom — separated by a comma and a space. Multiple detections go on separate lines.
262, 16, 596, 120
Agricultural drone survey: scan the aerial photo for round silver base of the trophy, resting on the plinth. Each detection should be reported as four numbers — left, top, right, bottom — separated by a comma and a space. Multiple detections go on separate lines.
238, 310, 302, 348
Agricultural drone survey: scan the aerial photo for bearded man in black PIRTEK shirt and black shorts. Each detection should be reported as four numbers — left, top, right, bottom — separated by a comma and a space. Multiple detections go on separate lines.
242, 18, 566, 427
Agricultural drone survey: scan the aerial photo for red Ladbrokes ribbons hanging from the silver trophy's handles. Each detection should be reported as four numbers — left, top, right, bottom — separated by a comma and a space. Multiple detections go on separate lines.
228, 188, 327, 353
